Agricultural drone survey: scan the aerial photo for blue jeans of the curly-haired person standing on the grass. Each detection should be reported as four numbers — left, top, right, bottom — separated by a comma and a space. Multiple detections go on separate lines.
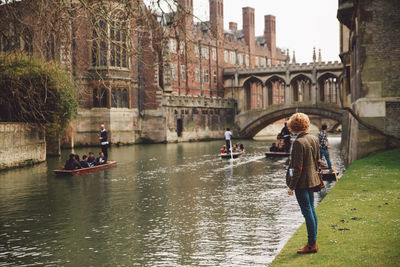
295, 188, 318, 245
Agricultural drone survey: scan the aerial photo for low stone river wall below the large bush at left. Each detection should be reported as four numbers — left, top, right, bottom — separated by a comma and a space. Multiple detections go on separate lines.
0, 122, 46, 169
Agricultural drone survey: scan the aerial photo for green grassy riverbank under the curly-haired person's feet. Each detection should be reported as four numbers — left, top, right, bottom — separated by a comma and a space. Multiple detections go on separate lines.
269, 149, 400, 266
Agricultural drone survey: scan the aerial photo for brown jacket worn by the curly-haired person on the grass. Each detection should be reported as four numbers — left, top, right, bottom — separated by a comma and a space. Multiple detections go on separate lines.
288, 133, 320, 190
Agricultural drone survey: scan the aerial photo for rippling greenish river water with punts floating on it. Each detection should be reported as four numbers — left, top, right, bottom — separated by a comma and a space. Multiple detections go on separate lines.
0, 137, 343, 266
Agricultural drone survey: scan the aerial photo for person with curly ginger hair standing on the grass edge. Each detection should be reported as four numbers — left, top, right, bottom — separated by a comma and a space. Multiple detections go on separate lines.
287, 113, 320, 254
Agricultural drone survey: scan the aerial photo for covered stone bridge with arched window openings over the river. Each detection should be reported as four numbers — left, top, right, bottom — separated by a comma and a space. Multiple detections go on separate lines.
224, 61, 343, 138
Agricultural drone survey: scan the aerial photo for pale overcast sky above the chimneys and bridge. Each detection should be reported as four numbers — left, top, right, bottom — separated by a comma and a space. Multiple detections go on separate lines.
193, 0, 340, 62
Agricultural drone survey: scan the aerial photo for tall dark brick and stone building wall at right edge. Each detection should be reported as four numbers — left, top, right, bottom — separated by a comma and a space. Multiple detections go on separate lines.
338, 0, 400, 164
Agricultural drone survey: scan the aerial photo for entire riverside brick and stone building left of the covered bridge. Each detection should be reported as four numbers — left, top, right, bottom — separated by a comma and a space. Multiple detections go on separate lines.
0, 0, 286, 146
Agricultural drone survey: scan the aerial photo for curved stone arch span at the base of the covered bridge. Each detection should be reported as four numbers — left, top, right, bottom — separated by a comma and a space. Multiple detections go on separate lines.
237, 106, 343, 138
